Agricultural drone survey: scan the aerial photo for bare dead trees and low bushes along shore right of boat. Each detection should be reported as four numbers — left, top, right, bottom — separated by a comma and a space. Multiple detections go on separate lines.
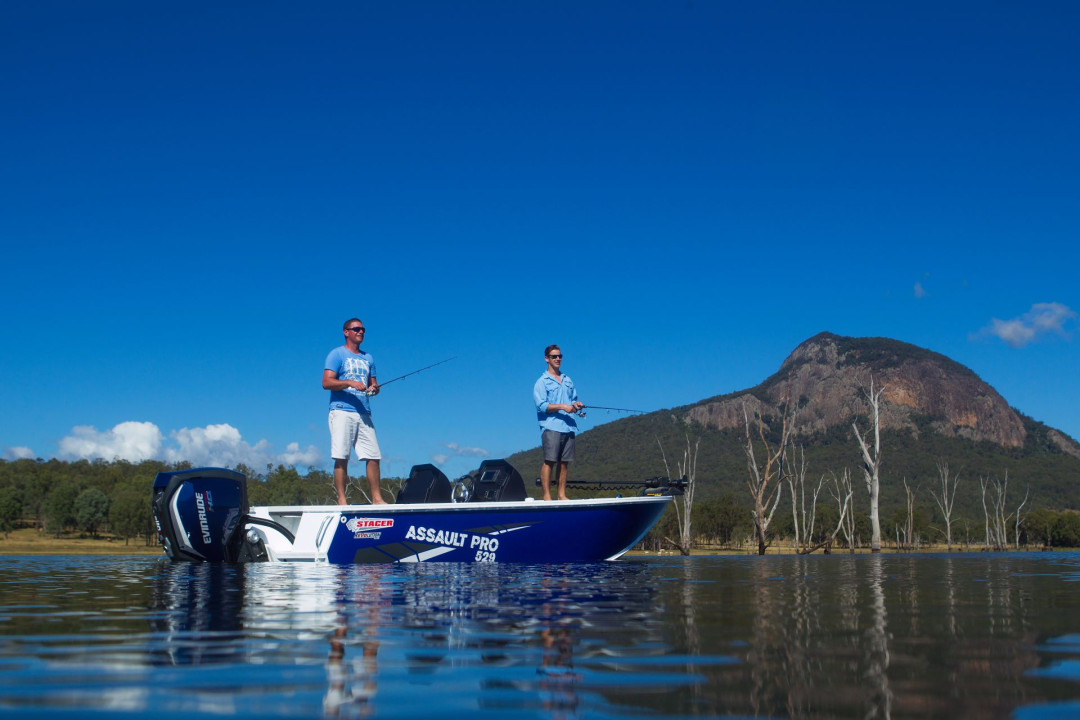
646, 377, 1080, 555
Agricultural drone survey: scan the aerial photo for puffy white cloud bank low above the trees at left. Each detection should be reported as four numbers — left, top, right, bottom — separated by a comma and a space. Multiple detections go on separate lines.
53, 422, 323, 471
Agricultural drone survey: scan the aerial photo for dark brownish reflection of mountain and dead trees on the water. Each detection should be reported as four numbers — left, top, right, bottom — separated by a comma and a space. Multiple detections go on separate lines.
660, 555, 1080, 718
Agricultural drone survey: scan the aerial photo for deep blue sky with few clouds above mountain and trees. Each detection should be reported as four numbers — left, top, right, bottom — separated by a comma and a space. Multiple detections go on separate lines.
0, 0, 1080, 477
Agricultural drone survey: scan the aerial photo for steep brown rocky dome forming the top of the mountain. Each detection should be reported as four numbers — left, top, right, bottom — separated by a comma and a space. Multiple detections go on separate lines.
684, 332, 1032, 454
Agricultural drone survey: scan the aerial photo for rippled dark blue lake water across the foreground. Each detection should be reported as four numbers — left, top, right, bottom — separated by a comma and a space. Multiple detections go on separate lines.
0, 553, 1080, 719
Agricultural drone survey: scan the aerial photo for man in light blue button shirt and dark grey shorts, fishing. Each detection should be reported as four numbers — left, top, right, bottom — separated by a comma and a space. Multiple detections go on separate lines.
532, 345, 585, 500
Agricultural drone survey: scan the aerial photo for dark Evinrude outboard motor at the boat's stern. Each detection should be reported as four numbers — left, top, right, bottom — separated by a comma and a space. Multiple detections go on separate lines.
153, 467, 248, 562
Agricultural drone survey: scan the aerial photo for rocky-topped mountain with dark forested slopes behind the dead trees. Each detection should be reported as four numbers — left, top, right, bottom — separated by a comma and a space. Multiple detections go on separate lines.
509, 332, 1080, 518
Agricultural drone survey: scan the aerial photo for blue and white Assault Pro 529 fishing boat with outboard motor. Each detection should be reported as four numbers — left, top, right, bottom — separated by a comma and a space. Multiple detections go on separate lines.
153, 460, 686, 563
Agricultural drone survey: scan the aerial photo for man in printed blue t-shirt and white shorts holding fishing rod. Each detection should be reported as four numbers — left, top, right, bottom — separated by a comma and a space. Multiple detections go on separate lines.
323, 317, 386, 505
